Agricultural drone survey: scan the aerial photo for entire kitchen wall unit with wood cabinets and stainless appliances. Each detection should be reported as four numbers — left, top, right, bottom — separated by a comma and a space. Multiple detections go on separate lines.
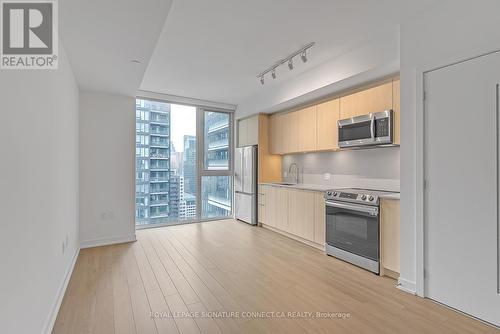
235, 76, 400, 279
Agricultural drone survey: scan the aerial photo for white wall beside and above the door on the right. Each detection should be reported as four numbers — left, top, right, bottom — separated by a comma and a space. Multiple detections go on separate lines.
400, 0, 500, 294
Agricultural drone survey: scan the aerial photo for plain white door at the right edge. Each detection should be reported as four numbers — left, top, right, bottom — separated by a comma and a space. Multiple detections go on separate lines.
424, 53, 500, 325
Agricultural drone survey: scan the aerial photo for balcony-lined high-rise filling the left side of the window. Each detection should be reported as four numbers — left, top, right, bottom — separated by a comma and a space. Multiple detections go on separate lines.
136, 99, 170, 225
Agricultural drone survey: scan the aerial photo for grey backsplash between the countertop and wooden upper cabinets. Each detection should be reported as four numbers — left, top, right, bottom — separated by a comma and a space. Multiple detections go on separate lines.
282, 146, 400, 191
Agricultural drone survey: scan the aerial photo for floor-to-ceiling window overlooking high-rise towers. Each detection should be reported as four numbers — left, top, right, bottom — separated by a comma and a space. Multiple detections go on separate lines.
136, 98, 232, 227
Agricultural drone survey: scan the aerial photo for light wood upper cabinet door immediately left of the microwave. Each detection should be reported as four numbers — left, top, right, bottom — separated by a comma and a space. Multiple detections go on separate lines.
316, 99, 340, 151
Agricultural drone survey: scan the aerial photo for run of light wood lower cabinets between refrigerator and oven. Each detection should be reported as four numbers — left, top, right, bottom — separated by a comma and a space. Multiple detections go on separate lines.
259, 185, 326, 248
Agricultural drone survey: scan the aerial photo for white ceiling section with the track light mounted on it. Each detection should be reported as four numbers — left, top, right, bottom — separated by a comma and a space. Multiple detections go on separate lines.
140, 0, 435, 104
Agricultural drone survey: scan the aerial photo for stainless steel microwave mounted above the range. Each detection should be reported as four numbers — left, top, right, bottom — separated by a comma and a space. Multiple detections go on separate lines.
338, 110, 394, 148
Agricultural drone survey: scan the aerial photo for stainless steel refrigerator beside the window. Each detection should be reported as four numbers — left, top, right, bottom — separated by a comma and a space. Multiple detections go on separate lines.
234, 146, 257, 225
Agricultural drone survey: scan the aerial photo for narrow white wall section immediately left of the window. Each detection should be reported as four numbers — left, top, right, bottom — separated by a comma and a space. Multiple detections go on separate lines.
80, 91, 135, 248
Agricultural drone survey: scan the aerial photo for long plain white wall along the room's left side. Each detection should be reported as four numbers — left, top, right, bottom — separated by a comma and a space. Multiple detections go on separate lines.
0, 44, 79, 334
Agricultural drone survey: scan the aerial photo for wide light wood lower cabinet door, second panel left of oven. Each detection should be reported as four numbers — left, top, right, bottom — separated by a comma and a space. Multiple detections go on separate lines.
288, 189, 314, 241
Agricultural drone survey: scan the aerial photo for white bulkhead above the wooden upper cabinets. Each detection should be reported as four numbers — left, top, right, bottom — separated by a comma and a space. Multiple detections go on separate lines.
236, 31, 399, 119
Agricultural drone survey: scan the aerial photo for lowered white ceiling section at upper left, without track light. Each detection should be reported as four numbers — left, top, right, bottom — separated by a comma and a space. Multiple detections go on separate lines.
59, 0, 172, 96
